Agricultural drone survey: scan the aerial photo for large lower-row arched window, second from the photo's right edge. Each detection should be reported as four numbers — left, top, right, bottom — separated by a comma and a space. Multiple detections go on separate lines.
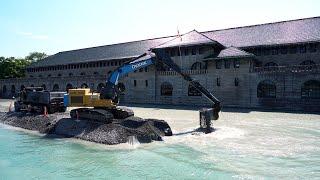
257, 80, 276, 98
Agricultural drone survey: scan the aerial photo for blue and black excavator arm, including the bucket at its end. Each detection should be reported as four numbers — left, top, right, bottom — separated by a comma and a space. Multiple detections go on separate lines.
100, 49, 221, 132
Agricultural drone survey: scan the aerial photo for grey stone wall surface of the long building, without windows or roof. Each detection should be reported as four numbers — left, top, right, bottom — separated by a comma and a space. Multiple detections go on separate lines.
0, 46, 320, 110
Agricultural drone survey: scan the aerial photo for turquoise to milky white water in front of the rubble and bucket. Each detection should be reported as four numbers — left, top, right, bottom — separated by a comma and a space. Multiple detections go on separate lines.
0, 109, 320, 179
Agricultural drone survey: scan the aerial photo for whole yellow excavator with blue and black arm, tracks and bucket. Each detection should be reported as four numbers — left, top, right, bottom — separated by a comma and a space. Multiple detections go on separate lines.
64, 49, 221, 133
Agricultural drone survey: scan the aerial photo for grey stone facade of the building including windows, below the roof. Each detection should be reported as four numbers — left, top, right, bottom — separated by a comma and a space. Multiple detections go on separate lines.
0, 18, 320, 111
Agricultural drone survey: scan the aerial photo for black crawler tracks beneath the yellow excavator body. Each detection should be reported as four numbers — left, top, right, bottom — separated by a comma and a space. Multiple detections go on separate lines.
70, 107, 134, 123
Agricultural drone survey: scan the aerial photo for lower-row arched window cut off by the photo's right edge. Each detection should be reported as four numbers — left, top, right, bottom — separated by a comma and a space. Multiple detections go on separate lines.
301, 80, 320, 99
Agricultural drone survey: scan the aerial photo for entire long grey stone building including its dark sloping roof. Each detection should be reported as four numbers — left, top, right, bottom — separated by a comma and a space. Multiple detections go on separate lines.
0, 17, 320, 111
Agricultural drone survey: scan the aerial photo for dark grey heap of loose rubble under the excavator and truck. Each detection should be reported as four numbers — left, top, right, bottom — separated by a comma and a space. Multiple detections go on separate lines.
0, 112, 172, 145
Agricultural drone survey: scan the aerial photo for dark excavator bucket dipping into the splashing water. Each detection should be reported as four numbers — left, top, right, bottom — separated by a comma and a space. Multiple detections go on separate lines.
199, 108, 219, 134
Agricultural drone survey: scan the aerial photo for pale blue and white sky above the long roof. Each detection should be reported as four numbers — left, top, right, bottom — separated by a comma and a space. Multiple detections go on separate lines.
0, 0, 320, 57
